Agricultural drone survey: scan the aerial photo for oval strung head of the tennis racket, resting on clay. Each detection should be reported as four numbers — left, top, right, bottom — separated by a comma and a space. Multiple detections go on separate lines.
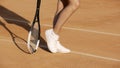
27, 22, 40, 54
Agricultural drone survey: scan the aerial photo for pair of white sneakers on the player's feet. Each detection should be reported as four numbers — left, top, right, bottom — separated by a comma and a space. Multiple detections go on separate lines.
45, 29, 71, 53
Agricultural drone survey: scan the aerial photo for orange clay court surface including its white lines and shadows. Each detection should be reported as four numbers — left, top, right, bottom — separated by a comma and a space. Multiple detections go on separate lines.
0, 0, 120, 68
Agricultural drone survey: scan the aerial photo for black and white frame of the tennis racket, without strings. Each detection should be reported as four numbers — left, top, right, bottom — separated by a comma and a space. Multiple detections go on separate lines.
27, 0, 41, 54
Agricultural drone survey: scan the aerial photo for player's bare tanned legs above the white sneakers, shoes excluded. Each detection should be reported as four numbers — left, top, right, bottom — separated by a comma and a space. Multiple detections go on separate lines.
53, 0, 79, 34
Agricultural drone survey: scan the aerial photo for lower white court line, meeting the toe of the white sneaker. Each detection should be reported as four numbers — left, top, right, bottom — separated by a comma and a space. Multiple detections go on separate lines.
0, 39, 120, 62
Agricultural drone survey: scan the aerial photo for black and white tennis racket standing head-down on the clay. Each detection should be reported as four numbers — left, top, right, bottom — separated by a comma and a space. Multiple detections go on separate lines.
27, 0, 41, 54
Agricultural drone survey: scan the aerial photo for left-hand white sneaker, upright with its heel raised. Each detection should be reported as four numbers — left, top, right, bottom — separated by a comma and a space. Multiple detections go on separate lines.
45, 29, 59, 53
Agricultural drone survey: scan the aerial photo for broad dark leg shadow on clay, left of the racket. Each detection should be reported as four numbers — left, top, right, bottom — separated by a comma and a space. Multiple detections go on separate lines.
0, 5, 30, 31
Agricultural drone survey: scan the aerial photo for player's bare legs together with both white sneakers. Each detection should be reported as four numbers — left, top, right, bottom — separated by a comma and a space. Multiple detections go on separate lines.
45, 0, 79, 53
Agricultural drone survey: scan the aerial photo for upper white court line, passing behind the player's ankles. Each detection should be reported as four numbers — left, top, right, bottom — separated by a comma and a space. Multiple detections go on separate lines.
3, 18, 120, 36
